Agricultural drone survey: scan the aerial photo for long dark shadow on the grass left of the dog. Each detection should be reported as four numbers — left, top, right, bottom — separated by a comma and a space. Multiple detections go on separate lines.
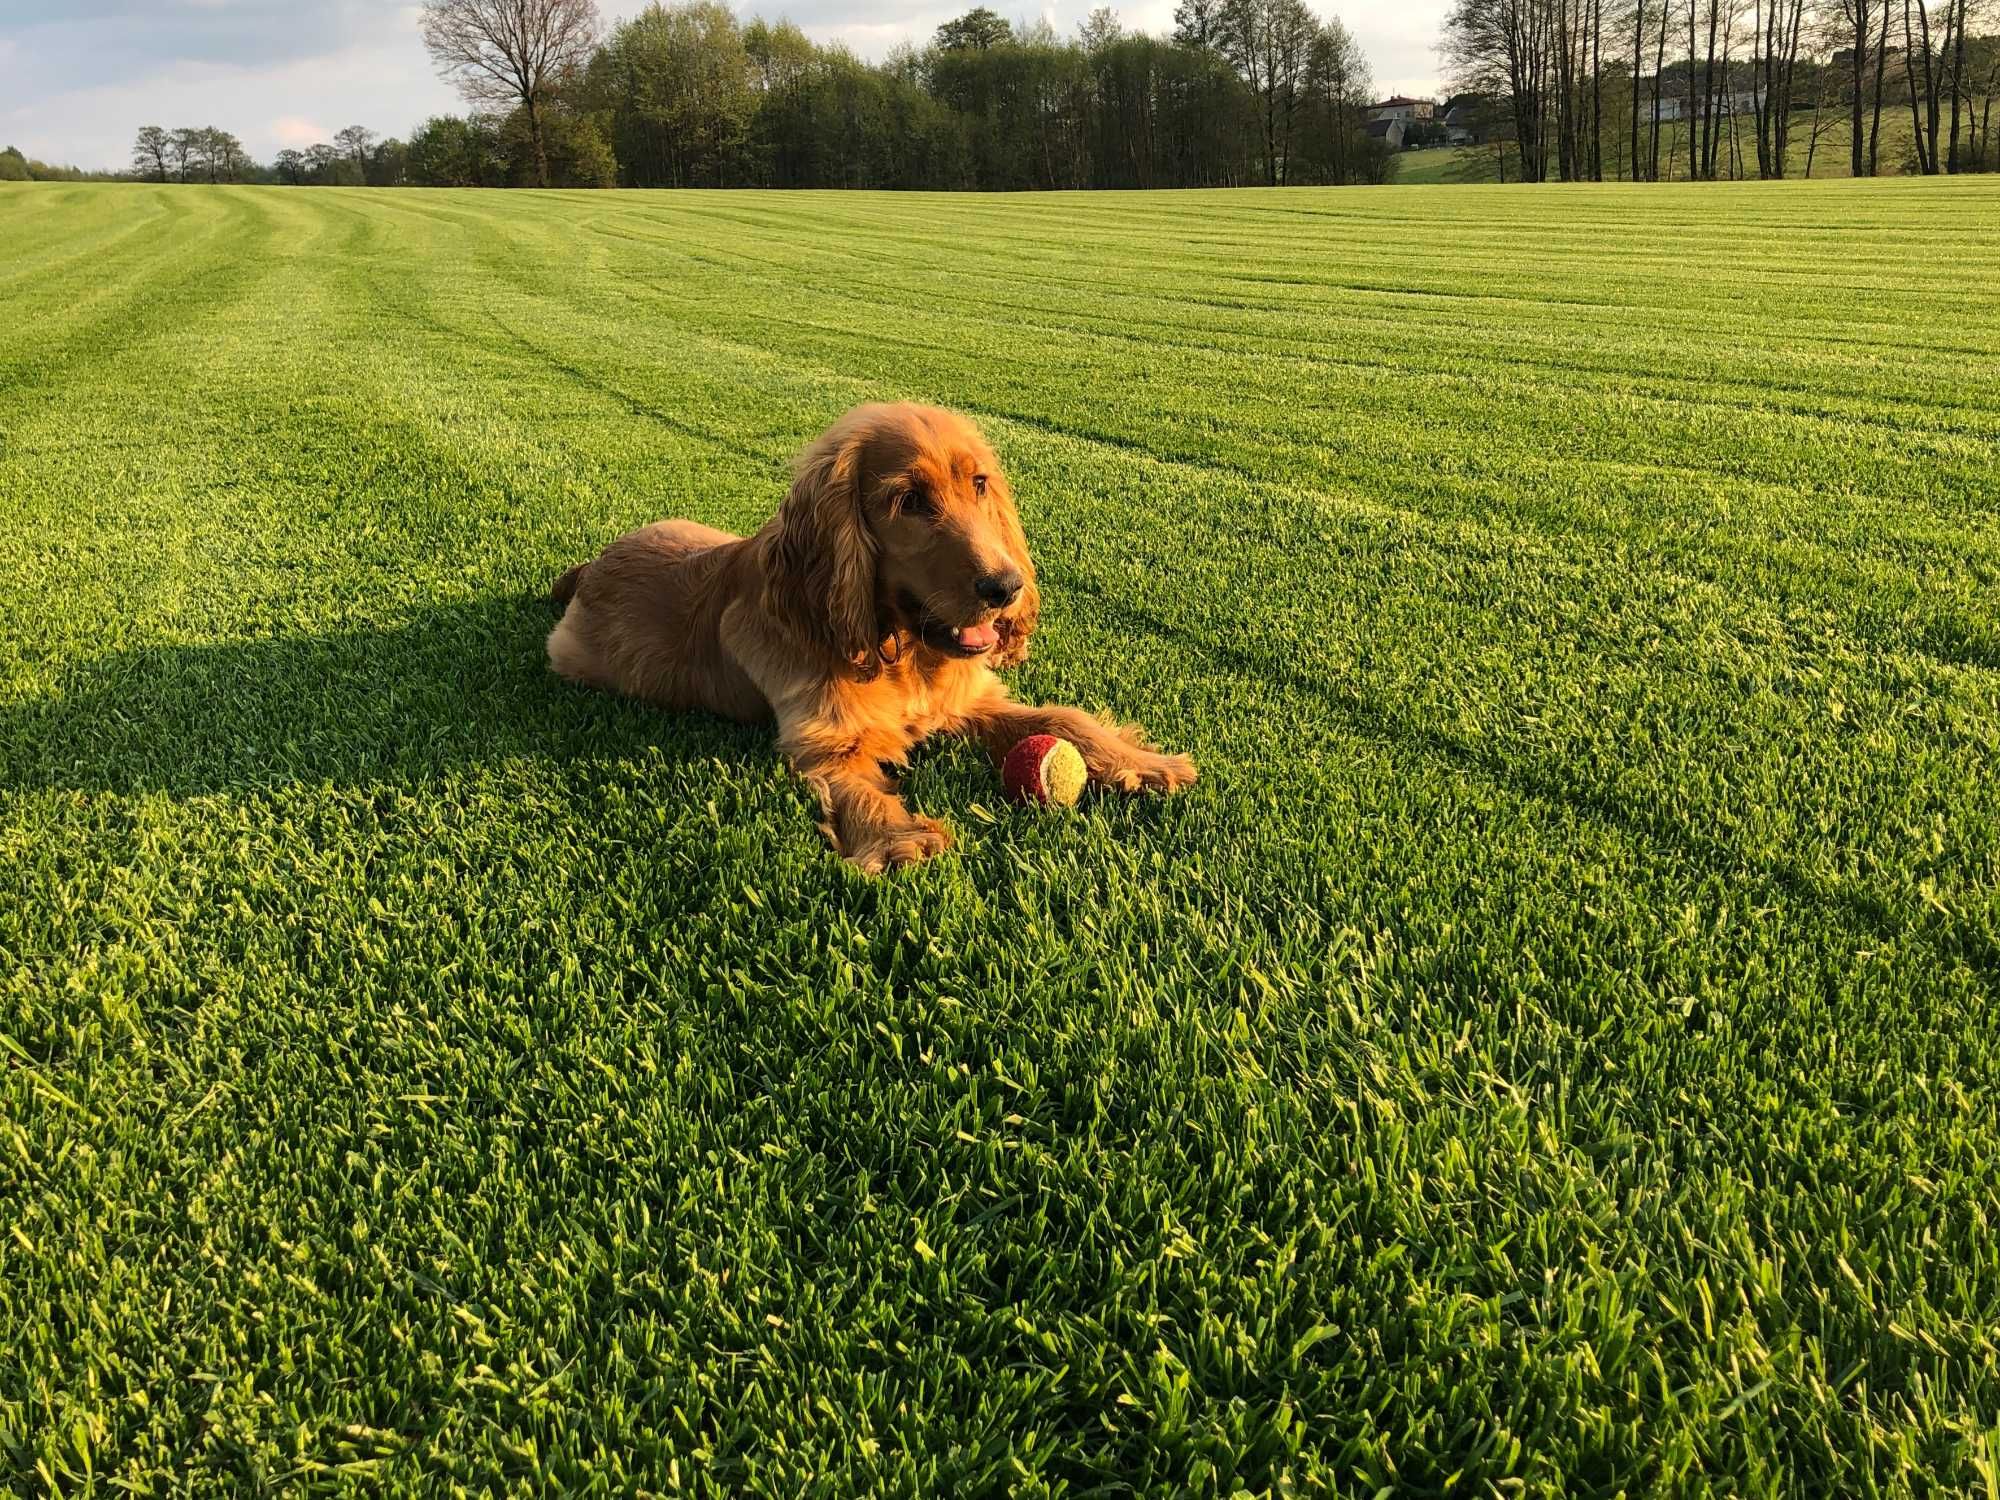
0, 598, 774, 794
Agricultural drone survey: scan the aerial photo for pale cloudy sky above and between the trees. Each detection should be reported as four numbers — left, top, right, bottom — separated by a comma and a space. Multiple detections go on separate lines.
0, 0, 1446, 168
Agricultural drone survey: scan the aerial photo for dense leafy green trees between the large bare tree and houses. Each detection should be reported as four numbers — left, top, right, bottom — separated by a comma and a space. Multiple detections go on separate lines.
570, 0, 1388, 190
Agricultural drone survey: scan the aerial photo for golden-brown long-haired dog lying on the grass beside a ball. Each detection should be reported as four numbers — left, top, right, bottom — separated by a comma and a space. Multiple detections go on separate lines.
548, 404, 1194, 874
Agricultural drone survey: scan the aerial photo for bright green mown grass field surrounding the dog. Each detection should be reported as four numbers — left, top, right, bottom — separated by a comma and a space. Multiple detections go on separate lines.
0, 180, 2000, 1496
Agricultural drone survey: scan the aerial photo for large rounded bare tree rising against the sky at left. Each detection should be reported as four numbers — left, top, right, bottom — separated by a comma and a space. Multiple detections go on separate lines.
422, 0, 598, 188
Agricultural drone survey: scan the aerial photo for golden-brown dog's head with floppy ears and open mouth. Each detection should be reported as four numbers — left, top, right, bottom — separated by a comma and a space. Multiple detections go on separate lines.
770, 404, 1040, 668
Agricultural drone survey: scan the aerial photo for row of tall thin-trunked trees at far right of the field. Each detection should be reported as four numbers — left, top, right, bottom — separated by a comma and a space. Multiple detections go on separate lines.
1442, 0, 2000, 182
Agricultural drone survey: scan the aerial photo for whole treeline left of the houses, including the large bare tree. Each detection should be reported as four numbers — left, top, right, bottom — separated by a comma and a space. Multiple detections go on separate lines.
134, 0, 1392, 190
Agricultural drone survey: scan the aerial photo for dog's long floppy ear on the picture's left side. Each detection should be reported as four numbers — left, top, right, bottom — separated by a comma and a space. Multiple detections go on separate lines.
766, 430, 880, 670
